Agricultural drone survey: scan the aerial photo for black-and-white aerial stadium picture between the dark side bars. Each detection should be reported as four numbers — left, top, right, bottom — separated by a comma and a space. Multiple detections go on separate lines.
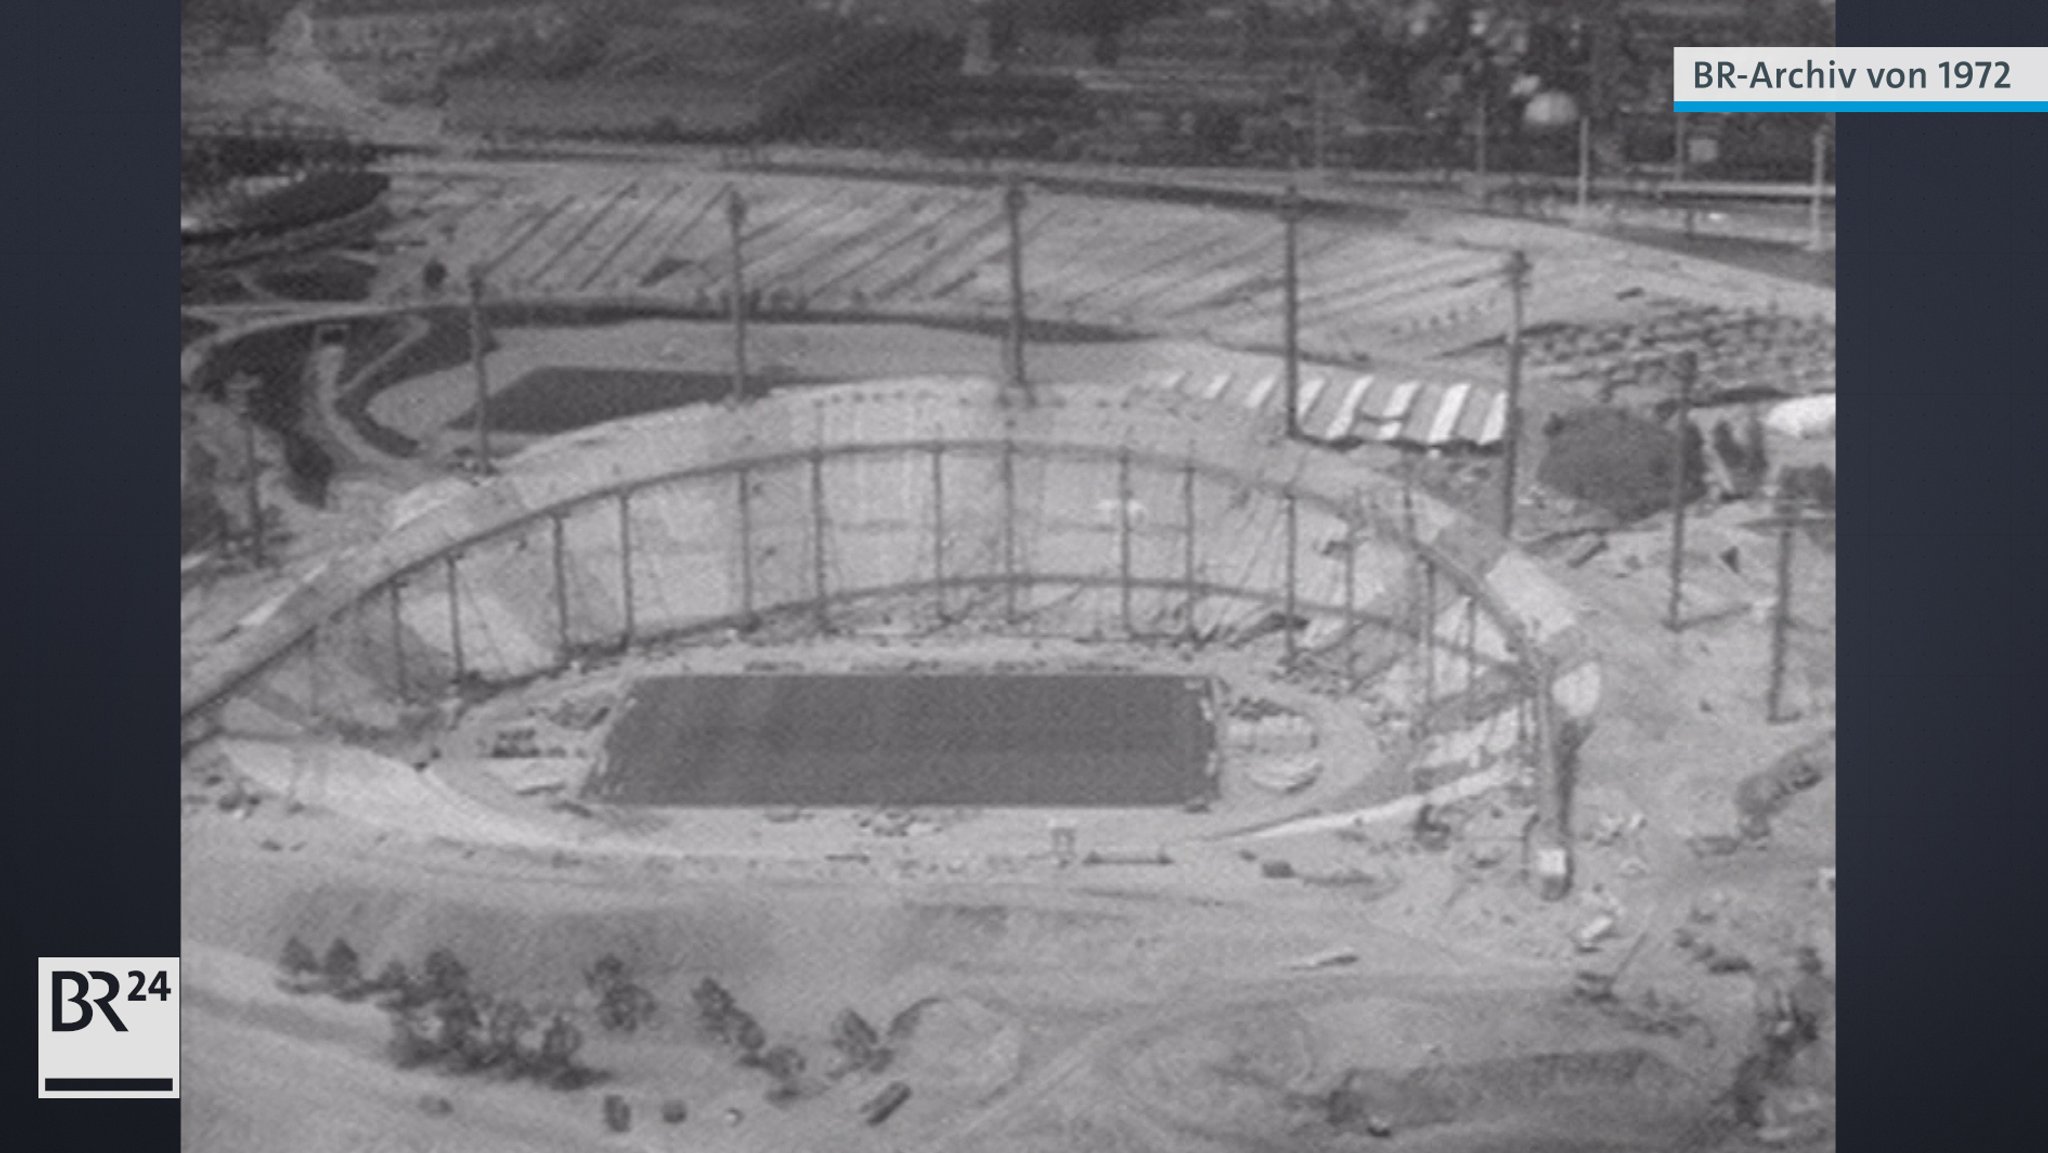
172, 0, 1843, 1153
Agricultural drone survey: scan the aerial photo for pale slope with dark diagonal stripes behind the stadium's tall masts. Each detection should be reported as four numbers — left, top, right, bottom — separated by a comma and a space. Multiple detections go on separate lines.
430, 176, 1501, 352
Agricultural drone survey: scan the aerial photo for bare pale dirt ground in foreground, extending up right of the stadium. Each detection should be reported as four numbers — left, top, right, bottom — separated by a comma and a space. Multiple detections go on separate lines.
184, 485, 1835, 1151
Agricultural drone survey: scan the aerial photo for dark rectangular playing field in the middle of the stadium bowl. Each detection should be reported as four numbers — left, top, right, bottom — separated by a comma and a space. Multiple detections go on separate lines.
588, 674, 1214, 807
